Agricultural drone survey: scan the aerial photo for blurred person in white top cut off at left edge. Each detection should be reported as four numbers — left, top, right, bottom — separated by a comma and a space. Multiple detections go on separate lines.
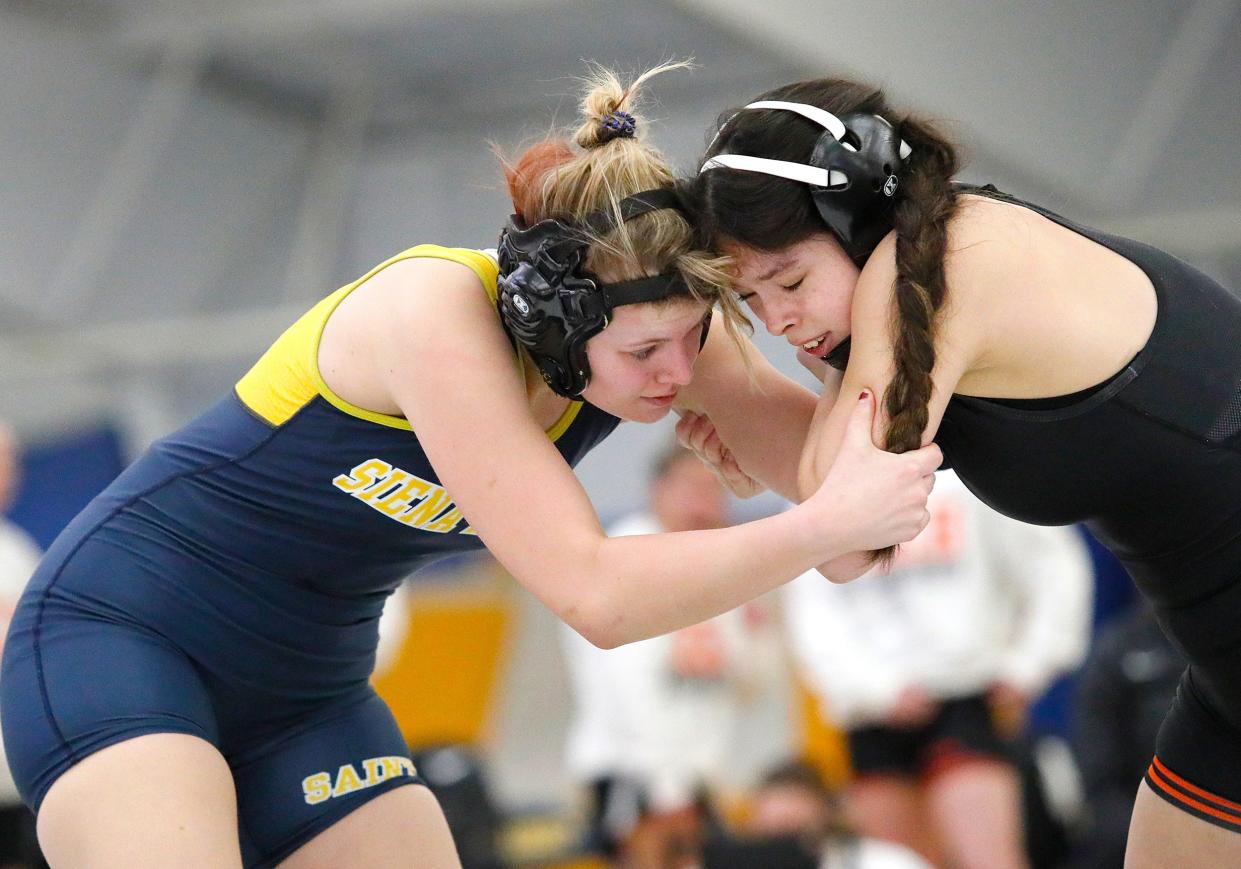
0, 423, 41, 869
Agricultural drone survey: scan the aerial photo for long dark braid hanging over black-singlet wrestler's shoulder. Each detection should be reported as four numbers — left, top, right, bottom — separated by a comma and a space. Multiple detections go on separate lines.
872, 122, 957, 565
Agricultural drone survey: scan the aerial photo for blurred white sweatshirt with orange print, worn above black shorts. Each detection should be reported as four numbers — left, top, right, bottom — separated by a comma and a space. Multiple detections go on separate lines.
783, 472, 1093, 729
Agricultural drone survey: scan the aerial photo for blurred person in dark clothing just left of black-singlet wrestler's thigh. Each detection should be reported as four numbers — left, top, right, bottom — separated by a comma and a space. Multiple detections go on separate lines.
1073, 601, 1185, 869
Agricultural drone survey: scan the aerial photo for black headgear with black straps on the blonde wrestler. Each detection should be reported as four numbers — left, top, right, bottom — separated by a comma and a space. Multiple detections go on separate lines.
496, 187, 705, 398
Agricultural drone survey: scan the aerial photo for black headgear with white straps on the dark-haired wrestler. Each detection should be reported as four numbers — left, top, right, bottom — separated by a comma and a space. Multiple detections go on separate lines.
699, 99, 912, 264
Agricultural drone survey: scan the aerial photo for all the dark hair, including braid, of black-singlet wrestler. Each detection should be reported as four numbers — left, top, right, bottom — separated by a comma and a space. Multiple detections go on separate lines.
683, 78, 958, 564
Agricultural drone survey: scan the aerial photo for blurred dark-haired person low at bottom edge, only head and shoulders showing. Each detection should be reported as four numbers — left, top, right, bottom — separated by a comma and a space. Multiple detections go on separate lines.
702, 761, 928, 869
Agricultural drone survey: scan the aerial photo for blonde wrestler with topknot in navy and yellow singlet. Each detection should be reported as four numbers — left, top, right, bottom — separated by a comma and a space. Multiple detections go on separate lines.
0, 67, 939, 869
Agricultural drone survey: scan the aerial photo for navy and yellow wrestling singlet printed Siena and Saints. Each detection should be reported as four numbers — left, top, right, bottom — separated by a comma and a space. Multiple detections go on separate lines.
0, 246, 617, 867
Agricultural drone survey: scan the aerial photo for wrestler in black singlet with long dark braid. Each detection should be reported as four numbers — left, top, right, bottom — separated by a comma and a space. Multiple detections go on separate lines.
680, 79, 1241, 867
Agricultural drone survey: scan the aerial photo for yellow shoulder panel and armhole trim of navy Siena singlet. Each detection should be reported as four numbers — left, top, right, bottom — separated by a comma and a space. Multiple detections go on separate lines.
236, 245, 581, 441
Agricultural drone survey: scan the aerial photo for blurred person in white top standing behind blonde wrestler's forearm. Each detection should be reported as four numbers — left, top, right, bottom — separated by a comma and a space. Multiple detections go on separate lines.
562, 447, 751, 864
